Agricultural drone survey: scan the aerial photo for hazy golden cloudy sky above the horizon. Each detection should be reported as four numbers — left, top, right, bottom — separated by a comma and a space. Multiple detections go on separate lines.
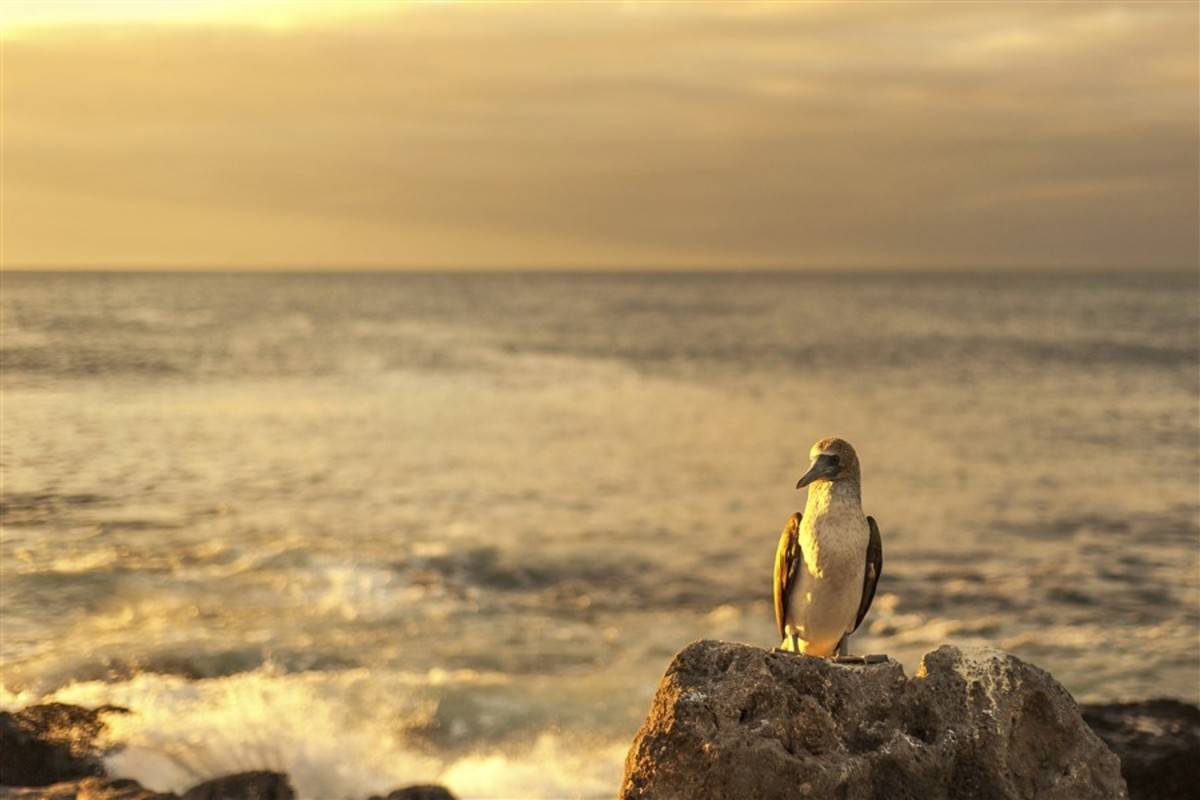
0, 0, 1200, 270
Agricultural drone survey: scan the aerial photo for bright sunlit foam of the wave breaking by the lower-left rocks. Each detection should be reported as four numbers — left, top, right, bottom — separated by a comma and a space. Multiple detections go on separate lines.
0, 667, 628, 800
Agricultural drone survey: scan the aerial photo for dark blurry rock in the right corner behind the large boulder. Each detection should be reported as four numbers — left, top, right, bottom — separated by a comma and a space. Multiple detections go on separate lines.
1082, 698, 1200, 800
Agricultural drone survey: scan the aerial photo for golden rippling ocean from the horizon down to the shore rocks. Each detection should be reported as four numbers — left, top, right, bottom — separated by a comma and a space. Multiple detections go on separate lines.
0, 272, 1200, 800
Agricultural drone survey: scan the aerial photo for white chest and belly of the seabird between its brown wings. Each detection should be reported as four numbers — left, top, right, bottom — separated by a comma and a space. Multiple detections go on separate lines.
787, 497, 870, 655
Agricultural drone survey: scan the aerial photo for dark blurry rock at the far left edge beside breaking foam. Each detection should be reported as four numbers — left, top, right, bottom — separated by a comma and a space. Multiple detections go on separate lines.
0, 703, 127, 786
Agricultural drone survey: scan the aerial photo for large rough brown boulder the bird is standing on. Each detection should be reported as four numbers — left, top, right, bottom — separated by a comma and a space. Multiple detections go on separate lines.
620, 642, 1128, 800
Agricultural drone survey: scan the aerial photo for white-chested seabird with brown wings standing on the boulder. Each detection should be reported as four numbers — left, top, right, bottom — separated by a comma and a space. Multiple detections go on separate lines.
774, 437, 883, 658
